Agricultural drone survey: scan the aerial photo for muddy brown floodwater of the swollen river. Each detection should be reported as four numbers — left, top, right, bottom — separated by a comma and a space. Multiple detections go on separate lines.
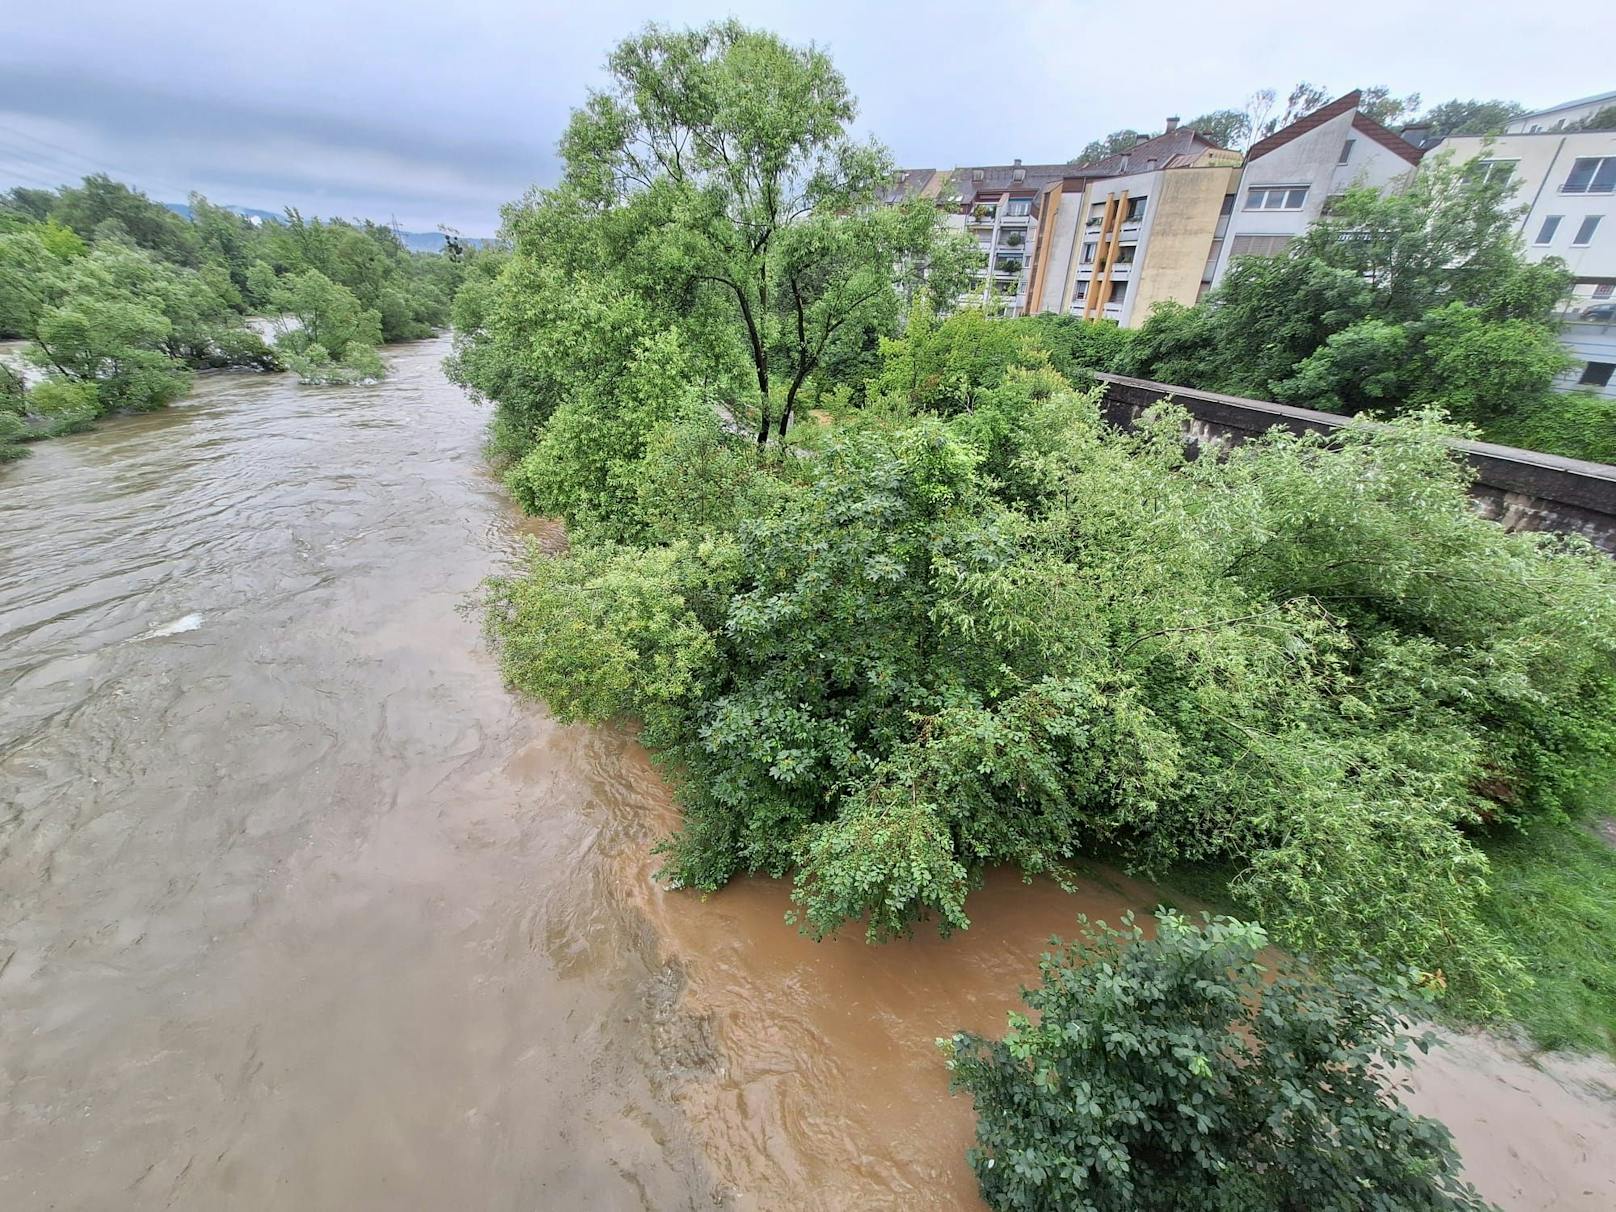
0, 341, 1616, 1210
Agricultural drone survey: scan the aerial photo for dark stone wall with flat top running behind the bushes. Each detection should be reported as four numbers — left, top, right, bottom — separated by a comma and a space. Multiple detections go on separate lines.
1094, 373, 1616, 554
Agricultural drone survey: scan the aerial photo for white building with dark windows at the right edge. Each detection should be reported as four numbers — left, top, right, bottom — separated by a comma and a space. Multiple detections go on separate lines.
1433, 110, 1616, 396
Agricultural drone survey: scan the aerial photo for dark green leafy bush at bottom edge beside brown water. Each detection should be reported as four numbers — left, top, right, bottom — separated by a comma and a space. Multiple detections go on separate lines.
939, 910, 1487, 1212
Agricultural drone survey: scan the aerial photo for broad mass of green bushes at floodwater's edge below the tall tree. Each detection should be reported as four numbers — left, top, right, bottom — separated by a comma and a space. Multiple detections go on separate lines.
491, 367, 1616, 1013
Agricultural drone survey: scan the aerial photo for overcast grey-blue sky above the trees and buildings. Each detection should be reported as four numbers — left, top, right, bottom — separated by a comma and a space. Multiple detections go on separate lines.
0, 0, 1616, 234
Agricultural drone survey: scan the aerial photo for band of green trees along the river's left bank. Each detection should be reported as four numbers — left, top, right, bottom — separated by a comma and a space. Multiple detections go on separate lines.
0, 176, 462, 457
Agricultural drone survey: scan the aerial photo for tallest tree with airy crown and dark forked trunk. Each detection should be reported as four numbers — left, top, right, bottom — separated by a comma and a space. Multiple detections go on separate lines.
561, 21, 949, 443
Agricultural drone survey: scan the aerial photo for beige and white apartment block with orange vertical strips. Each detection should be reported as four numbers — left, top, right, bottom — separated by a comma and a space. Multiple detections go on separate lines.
1026, 118, 1241, 328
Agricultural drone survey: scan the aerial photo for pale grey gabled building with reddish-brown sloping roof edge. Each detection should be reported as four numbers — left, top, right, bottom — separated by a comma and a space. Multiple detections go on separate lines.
1210, 90, 1420, 284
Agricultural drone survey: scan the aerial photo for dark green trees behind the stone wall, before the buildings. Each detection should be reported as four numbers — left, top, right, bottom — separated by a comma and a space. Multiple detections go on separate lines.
1018, 162, 1616, 462
